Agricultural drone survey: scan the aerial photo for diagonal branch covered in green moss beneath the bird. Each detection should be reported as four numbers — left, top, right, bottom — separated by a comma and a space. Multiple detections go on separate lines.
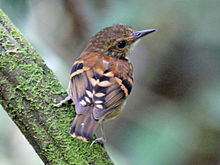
0, 10, 113, 165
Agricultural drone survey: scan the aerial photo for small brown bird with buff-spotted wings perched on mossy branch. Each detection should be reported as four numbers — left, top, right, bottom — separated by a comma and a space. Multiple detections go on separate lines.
56, 24, 155, 144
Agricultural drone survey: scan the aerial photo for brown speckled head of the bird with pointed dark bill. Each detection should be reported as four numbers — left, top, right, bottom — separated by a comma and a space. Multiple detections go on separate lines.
86, 24, 155, 59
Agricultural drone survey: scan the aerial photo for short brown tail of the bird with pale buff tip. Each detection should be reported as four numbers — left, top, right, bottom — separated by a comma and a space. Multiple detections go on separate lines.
70, 113, 98, 142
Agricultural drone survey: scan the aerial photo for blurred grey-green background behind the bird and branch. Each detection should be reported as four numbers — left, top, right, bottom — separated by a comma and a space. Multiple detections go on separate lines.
0, 0, 220, 165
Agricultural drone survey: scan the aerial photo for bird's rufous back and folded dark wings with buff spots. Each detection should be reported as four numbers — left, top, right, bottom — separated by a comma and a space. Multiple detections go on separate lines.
70, 53, 133, 119
